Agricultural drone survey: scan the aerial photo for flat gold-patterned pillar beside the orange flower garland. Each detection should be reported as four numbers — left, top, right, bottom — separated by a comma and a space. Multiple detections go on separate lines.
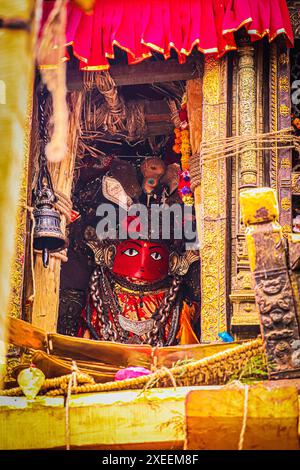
199, 58, 228, 342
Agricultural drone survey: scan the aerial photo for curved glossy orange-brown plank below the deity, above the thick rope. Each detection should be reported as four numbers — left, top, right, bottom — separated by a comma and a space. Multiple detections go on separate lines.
9, 317, 250, 367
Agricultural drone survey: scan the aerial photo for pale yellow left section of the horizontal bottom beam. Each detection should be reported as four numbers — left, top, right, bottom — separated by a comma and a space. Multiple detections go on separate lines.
0, 387, 190, 450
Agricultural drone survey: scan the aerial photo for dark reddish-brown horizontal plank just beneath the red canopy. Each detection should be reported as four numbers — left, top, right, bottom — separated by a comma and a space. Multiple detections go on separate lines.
68, 59, 199, 91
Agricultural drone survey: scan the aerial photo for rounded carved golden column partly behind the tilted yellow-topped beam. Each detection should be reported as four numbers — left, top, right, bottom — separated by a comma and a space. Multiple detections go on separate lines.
230, 34, 263, 336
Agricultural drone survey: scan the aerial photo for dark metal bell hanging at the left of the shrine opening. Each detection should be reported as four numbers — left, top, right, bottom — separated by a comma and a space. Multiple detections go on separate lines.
33, 184, 66, 268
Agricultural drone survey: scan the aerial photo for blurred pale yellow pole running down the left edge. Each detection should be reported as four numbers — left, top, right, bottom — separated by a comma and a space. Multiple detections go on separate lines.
0, 0, 35, 388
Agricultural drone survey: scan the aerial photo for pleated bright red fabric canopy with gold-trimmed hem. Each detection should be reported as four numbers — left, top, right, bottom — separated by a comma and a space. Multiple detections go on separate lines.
42, 0, 293, 70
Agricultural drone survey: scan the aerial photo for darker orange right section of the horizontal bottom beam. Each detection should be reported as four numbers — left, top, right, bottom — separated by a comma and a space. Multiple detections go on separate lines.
186, 383, 299, 450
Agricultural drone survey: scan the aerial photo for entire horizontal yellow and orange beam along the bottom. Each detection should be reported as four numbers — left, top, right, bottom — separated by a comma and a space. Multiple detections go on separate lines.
0, 383, 300, 450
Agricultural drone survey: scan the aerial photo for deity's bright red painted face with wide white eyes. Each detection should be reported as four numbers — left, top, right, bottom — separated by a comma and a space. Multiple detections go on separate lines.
112, 240, 169, 282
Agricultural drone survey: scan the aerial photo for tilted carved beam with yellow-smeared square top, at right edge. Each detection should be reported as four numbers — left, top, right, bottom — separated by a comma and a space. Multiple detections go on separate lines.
240, 188, 300, 379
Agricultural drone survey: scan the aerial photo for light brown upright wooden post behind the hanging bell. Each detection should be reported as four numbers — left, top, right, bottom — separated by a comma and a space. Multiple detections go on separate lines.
32, 91, 83, 332
